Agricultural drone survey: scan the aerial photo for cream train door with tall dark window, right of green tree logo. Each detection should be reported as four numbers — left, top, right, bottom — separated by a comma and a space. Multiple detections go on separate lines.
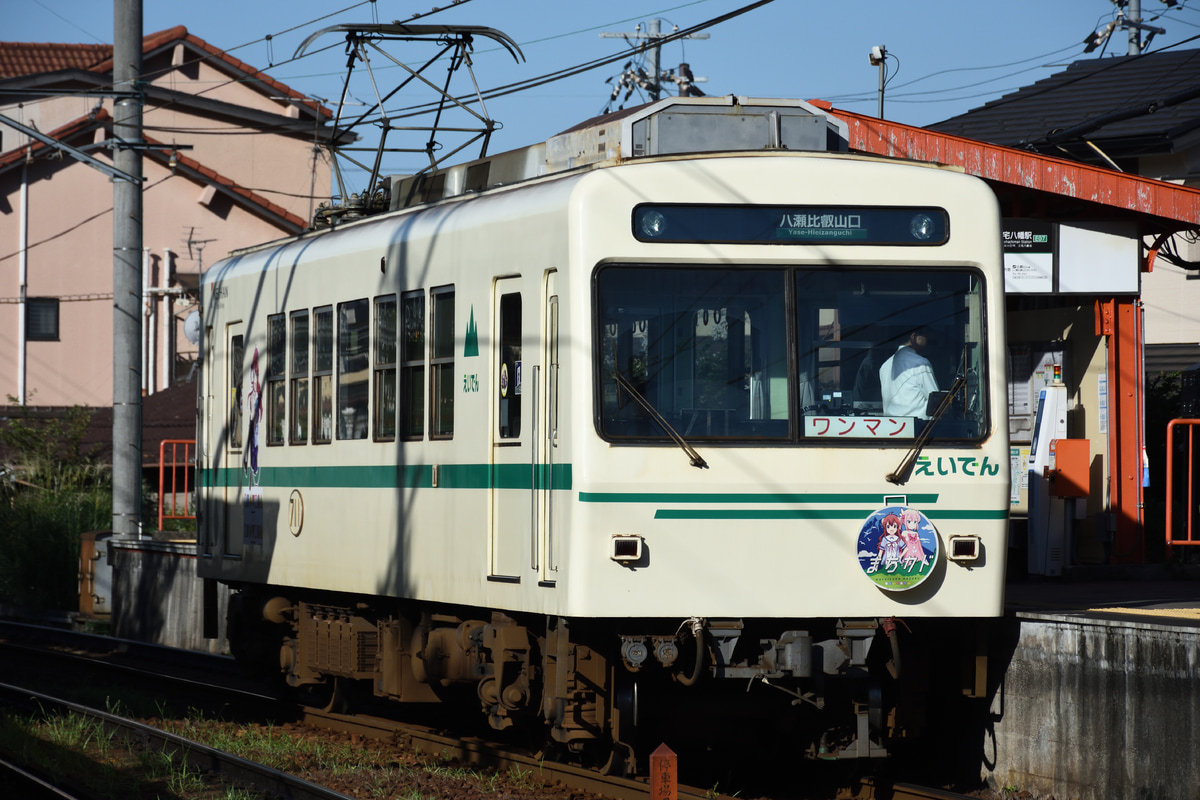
490, 278, 536, 581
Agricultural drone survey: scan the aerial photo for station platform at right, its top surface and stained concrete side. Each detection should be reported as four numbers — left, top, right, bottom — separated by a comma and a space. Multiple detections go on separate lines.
980, 565, 1200, 800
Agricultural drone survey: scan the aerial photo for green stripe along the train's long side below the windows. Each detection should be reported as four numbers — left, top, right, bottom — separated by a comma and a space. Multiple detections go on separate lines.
202, 464, 571, 491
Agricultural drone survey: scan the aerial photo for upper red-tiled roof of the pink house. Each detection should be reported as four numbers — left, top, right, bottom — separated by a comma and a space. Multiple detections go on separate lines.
0, 25, 334, 118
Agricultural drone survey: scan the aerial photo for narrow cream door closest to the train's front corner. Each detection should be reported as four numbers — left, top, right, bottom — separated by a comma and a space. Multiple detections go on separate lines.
533, 270, 565, 585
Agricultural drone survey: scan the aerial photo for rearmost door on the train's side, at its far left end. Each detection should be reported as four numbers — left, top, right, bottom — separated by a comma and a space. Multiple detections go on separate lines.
224, 323, 244, 555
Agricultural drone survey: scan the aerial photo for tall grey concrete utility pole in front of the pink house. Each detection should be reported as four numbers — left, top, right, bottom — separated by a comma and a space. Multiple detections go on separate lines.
113, 0, 143, 536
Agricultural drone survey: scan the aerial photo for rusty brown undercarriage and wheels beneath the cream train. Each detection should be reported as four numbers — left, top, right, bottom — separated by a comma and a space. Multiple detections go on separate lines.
229, 587, 986, 775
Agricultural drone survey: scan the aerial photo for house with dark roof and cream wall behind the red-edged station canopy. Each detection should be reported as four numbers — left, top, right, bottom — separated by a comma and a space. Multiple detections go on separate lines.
928, 49, 1200, 377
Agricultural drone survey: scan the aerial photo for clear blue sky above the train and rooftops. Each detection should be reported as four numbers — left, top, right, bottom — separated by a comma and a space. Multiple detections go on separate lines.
9, 0, 1200, 193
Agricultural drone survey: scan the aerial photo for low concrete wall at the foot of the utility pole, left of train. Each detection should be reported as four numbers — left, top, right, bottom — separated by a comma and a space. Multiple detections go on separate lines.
108, 540, 229, 654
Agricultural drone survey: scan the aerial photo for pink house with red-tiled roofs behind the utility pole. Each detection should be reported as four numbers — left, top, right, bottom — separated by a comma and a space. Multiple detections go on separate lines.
0, 26, 343, 412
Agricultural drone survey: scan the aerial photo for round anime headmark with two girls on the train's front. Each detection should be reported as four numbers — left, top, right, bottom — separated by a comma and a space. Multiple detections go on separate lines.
858, 506, 938, 591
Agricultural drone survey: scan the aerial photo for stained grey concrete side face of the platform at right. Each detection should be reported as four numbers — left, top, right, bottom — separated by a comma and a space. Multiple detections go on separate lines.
983, 614, 1200, 800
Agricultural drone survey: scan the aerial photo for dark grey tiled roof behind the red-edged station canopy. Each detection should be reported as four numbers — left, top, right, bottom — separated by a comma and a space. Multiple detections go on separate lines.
928, 49, 1200, 158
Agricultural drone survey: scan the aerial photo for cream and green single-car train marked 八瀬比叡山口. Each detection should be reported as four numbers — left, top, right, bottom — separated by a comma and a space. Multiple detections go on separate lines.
197, 96, 1010, 774
